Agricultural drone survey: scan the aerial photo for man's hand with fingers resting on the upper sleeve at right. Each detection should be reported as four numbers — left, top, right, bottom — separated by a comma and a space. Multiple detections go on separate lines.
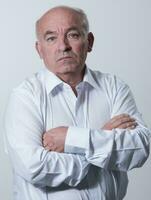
102, 114, 137, 130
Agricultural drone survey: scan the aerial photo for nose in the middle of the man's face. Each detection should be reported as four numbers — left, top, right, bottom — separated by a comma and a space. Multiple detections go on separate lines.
58, 37, 72, 52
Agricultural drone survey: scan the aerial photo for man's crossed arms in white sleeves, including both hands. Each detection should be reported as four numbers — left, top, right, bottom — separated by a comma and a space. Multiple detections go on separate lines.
5, 82, 150, 187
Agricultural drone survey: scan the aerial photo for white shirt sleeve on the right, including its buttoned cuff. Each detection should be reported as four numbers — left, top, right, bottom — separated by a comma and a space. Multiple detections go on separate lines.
65, 84, 151, 171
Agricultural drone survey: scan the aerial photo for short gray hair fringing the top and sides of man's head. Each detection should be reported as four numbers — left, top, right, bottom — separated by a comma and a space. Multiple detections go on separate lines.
36, 6, 89, 38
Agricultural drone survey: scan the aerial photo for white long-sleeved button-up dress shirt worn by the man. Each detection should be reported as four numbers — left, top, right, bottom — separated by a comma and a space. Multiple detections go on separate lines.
5, 68, 150, 200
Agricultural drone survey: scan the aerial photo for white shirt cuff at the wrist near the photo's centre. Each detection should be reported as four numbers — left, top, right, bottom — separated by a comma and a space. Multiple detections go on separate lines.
64, 126, 90, 154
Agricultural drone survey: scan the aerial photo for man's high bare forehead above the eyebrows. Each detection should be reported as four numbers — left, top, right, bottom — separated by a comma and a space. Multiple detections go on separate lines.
38, 9, 82, 33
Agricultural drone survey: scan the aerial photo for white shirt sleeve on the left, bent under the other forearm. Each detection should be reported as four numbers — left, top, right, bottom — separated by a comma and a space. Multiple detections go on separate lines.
5, 88, 89, 187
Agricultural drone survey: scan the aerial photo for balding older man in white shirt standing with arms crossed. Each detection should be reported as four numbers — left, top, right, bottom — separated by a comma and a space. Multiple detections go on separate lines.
5, 6, 150, 200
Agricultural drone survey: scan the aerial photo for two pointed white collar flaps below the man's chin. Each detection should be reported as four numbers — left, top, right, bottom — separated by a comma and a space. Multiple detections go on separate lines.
44, 67, 98, 94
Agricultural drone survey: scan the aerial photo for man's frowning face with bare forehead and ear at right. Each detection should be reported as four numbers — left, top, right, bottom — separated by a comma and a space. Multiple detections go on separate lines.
36, 9, 93, 75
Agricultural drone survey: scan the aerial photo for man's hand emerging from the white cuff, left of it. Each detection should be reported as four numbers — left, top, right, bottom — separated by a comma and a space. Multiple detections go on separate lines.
43, 126, 68, 153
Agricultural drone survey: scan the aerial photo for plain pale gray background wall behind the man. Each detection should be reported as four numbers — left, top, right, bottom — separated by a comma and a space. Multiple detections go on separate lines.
0, 0, 151, 200
